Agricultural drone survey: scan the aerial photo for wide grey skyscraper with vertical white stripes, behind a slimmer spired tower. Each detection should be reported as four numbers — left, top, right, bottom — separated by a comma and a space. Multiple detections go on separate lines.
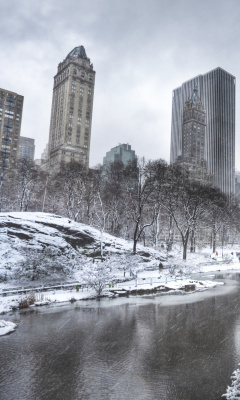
170, 68, 235, 195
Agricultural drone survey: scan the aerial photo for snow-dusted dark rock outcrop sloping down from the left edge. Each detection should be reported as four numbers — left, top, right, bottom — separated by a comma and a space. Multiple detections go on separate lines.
0, 212, 164, 281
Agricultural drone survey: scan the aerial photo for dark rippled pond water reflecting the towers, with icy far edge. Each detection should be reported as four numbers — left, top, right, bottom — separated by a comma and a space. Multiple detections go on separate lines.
0, 274, 240, 400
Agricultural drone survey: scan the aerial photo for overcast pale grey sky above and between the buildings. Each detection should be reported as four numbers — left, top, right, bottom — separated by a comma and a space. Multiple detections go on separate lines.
0, 0, 240, 169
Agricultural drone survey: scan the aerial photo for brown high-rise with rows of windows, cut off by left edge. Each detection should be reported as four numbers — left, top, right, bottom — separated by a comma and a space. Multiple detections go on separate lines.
0, 89, 24, 173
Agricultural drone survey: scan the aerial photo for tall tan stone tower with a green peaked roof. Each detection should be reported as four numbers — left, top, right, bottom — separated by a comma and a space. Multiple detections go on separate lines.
49, 46, 95, 172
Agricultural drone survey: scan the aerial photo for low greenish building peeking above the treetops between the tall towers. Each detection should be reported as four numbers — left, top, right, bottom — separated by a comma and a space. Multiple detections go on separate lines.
103, 144, 136, 166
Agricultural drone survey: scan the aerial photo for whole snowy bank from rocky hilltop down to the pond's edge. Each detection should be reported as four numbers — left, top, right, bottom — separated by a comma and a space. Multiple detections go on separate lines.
0, 209, 239, 314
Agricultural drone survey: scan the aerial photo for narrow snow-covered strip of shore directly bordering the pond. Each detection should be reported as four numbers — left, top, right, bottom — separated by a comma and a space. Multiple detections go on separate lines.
0, 272, 227, 315
